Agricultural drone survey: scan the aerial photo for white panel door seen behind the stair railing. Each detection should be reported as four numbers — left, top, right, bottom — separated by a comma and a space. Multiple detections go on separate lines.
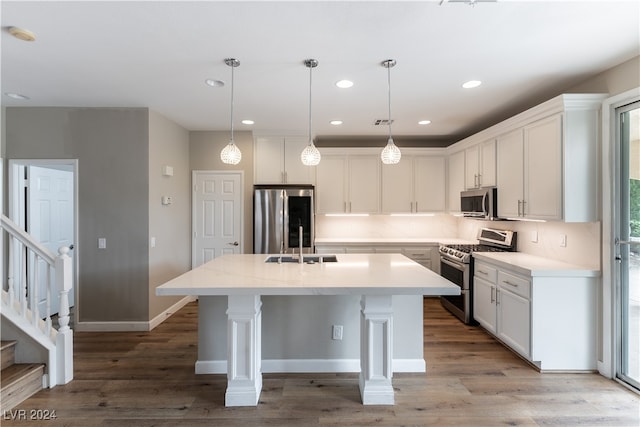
27, 166, 74, 316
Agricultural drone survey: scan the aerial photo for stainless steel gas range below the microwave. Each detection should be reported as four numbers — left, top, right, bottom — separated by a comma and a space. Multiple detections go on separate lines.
440, 228, 517, 324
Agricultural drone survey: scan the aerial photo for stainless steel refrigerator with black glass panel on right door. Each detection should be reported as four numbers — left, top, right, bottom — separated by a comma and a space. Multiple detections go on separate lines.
253, 185, 314, 254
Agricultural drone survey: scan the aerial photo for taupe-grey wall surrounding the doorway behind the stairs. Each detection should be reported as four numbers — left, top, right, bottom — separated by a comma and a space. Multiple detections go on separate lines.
5, 107, 149, 322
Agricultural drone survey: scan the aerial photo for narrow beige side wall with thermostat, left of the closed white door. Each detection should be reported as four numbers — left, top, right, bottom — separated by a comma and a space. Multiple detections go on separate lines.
149, 111, 191, 319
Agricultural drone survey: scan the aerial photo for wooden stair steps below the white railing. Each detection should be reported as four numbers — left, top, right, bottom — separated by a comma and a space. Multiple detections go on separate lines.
0, 341, 45, 414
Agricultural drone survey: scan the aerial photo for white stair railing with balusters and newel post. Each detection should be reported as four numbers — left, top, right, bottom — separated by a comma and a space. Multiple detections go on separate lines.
0, 215, 73, 387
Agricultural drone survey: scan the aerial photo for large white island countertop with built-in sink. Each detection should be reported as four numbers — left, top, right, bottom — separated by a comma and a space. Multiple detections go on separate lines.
156, 254, 460, 295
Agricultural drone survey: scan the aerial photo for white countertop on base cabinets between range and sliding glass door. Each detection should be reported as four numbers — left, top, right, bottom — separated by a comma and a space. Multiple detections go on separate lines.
473, 252, 600, 277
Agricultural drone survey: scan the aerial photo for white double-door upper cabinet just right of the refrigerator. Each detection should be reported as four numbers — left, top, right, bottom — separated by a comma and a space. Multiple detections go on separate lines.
316, 155, 380, 214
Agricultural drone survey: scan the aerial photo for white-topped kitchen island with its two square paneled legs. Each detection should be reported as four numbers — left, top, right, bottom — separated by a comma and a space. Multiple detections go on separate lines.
156, 254, 460, 406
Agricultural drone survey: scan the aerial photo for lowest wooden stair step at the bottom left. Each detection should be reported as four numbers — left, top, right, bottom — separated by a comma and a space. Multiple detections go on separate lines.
0, 363, 44, 413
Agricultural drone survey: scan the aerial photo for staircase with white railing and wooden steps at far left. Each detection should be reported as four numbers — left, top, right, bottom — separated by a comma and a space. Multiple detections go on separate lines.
0, 214, 73, 411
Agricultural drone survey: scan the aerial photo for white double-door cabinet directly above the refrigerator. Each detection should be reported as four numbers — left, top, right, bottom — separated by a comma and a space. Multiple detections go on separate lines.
254, 137, 315, 184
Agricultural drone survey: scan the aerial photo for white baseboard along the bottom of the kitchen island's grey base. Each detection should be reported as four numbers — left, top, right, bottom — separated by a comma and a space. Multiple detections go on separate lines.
195, 359, 427, 374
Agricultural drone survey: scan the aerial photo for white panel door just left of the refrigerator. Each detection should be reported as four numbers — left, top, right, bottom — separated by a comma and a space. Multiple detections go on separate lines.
191, 171, 243, 268
